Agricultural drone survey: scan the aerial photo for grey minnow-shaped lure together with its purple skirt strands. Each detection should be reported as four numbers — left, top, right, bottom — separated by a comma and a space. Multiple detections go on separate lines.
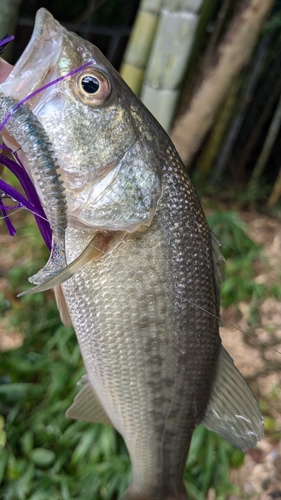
0, 59, 91, 284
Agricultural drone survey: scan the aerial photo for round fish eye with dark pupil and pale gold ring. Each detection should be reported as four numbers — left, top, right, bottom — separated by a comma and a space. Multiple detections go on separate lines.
74, 68, 111, 106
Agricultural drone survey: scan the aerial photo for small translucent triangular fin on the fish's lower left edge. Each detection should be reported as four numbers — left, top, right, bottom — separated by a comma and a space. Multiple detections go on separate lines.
66, 377, 112, 427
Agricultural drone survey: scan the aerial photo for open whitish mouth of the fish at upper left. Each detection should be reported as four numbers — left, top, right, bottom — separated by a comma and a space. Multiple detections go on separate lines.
0, 8, 64, 102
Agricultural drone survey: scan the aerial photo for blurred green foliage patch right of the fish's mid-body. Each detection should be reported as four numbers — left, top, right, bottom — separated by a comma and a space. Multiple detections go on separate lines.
208, 211, 265, 307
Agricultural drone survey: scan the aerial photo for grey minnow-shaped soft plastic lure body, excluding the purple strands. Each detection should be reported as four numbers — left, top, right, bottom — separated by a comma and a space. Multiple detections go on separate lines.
0, 94, 67, 284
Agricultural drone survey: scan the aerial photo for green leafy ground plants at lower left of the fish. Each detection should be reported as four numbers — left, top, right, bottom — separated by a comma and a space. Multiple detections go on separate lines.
0, 296, 130, 500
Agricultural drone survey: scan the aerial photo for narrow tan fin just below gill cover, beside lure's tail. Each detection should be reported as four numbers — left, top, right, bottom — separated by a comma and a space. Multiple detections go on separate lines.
18, 231, 125, 297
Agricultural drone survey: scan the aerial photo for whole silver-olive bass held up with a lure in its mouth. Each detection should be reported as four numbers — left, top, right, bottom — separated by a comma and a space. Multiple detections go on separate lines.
0, 9, 263, 500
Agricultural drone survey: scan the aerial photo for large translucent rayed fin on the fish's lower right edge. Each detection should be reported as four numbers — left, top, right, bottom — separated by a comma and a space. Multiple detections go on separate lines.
202, 346, 264, 450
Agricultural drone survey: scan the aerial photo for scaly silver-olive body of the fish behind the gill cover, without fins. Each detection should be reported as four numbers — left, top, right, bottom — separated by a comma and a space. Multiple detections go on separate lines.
63, 178, 219, 499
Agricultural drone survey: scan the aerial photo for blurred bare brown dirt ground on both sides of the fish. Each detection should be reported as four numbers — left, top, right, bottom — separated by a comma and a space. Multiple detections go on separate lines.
0, 207, 281, 500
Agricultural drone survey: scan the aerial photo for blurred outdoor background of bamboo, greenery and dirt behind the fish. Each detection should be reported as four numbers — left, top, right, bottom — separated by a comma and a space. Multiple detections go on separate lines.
0, 0, 281, 500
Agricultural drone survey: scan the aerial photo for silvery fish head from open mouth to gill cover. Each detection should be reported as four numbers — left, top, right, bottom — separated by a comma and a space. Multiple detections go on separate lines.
0, 8, 163, 231
